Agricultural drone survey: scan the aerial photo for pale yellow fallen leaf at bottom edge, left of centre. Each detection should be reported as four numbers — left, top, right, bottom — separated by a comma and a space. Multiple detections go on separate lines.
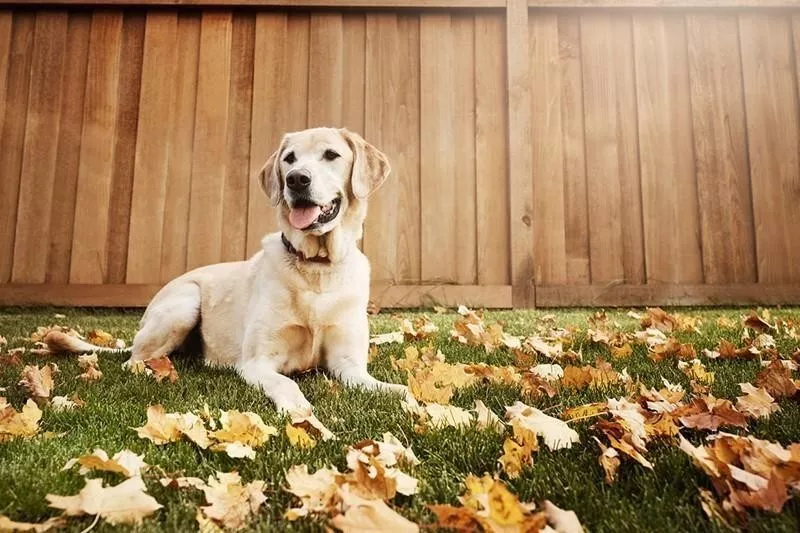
199, 472, 267, 529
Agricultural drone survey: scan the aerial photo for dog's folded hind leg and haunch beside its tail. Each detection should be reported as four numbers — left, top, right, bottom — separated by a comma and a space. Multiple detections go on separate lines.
129, 279, 200, 362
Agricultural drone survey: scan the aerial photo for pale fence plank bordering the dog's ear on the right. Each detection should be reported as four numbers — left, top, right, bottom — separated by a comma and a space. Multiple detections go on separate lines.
364, 13, 401, 282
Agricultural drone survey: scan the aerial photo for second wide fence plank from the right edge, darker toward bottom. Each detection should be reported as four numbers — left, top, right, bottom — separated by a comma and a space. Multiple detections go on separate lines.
686, 13, 757, 284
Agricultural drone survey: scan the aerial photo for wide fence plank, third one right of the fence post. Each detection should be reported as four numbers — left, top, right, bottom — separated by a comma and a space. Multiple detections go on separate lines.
580, 13, 646, 284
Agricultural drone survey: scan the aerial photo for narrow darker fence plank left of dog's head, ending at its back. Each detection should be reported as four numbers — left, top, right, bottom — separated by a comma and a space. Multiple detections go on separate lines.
222, 13, 255, 261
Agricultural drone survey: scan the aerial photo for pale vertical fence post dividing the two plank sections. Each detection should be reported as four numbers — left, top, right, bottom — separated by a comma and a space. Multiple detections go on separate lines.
506, 0, 536, 308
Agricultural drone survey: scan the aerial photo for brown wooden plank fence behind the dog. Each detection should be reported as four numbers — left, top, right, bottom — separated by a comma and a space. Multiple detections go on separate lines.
0, 0, 800, 307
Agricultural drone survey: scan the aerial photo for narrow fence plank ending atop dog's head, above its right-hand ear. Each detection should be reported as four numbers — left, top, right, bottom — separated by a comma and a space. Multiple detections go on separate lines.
340, 13, 367, 134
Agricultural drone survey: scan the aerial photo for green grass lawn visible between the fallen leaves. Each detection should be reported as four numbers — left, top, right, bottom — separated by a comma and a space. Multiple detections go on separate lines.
0, 309, 800, 532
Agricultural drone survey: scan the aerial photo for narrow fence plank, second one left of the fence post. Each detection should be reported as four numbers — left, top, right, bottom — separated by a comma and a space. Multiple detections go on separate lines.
450, 14, 478, 285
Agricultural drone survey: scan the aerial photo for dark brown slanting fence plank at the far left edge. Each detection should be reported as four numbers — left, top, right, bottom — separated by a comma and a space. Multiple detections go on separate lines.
0, 13, 36, 283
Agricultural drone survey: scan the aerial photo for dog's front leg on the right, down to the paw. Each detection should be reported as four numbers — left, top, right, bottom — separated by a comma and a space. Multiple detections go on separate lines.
325, 317, 411, 400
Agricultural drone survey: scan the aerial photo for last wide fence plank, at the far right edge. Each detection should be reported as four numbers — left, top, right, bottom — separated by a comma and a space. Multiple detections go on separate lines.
739, 13, 800, 283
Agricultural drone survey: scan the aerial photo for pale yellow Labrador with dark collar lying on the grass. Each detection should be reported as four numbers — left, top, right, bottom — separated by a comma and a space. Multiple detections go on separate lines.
49, 128, 411, 412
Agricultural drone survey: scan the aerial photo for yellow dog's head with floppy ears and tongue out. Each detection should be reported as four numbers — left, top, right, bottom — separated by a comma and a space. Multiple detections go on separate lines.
259, 128, 389, 235
